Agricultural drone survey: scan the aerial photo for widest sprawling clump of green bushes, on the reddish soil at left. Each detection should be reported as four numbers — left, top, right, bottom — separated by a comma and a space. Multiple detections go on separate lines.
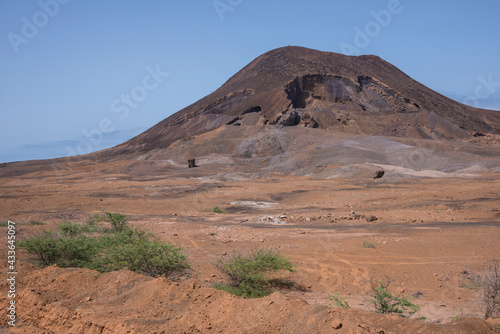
19, 215, 189, 277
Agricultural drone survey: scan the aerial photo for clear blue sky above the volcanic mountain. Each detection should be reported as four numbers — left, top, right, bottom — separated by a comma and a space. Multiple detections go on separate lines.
0, 0, 500, 162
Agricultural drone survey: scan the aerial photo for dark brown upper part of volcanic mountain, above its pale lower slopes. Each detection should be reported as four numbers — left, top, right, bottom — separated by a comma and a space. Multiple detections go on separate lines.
102, 46, 500, 157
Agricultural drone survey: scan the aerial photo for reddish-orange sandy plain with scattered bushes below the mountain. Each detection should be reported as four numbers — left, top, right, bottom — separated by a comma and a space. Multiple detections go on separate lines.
0, 162, 500, 333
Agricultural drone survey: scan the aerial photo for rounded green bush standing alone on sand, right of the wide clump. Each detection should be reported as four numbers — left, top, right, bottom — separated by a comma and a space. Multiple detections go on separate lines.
216, 249, 295, 298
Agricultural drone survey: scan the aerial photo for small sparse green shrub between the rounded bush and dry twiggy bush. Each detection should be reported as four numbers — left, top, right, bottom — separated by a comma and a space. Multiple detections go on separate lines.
371, 280, 420, 315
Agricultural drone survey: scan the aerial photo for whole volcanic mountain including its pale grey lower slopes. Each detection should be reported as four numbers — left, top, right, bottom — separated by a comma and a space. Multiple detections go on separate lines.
0, 46, 500, 177
